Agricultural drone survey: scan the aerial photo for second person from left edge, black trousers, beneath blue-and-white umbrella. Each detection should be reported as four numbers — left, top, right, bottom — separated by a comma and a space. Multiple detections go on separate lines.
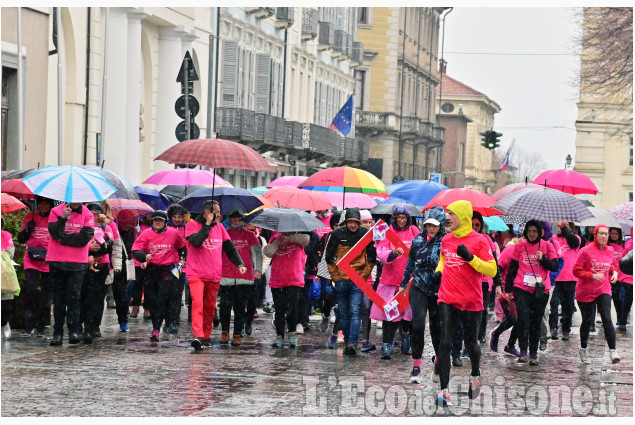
18, 196, 53, 336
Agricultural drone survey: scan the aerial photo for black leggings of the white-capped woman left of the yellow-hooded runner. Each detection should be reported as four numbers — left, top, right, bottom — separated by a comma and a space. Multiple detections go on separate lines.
409, 286, 441, 359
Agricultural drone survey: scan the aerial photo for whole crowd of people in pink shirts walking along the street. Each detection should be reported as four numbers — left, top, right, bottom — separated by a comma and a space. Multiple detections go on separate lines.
2, 197, 633, 406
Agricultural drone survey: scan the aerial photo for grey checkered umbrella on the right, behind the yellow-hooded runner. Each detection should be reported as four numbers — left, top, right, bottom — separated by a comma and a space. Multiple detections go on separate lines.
493, 187, 593, 221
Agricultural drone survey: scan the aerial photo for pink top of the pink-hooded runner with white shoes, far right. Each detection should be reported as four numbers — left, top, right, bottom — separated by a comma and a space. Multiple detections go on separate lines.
574, 242, 614, 303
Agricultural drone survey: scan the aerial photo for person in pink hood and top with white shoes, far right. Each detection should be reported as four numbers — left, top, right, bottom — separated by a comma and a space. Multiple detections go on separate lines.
573, 224, 620, 364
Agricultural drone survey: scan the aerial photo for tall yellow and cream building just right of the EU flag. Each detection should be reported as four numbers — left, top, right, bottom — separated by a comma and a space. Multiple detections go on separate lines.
355, 7, 444, 184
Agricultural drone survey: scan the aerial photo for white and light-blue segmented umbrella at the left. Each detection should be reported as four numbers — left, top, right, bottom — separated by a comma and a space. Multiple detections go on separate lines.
22, 165, 117, 202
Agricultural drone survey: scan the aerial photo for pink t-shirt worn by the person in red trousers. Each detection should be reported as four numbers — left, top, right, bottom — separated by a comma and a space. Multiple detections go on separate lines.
185, 220, 230, 282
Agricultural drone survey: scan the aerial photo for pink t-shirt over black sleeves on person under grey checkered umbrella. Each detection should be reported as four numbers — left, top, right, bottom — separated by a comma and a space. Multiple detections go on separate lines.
512, 240, 558, 294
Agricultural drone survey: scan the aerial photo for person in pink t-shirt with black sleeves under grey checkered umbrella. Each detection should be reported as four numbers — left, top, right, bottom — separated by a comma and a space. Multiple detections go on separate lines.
505, 220, 558, 366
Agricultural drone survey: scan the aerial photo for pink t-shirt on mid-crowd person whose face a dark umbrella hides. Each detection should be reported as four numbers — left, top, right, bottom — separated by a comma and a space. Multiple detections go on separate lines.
269, 233, 306, 288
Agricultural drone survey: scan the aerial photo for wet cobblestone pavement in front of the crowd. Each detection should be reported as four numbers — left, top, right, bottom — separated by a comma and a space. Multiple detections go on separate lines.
1, 309, 633, 417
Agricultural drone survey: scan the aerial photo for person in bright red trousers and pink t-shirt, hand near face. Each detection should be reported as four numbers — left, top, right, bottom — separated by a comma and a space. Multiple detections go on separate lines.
186, 200, 247, 351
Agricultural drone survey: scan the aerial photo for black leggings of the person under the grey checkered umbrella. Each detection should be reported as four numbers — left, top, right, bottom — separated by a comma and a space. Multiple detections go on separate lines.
514, 287, 549, 354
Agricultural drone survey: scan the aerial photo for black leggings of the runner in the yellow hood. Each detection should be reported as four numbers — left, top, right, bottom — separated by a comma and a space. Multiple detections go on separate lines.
438, 303, 482, 389
